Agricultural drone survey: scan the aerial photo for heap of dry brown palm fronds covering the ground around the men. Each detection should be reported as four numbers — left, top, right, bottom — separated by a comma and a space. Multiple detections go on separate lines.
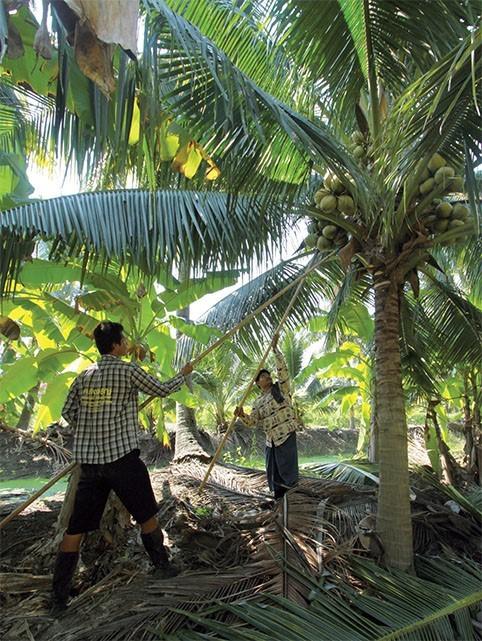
0, 462, 480, 641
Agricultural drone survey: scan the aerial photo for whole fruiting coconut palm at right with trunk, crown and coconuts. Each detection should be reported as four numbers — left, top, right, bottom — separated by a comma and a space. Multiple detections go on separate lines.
4, 0, 481, 568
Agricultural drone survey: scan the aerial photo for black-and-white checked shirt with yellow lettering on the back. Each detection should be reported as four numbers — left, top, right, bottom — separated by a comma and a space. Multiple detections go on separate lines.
62, 354, 184, 463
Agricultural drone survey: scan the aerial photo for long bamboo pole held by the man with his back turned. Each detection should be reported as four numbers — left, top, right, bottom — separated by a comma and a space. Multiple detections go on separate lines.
0, 252, 328, 530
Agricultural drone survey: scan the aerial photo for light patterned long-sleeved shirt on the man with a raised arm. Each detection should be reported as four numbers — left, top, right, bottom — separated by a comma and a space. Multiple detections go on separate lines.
245, 349, 298, 447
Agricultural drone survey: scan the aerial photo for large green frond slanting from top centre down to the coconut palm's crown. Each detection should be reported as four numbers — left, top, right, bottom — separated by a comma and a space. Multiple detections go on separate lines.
140, 0, 370, 198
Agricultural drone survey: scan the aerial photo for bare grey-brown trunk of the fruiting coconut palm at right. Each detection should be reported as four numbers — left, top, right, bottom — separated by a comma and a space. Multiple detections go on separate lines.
375, 284, 413, 570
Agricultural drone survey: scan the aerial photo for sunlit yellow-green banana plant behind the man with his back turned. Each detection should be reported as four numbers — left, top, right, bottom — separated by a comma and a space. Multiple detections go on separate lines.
0, 259, 233, 434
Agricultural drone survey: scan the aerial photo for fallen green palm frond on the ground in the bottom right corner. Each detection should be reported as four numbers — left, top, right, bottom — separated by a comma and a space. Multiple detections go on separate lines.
165, 558, 482, 641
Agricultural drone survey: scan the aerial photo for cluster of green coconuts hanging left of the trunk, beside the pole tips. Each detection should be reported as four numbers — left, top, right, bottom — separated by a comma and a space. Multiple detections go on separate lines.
305, 173, 356, 251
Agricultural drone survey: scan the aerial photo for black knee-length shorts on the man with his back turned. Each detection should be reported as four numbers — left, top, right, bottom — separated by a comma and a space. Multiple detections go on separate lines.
67, 450, 158, 534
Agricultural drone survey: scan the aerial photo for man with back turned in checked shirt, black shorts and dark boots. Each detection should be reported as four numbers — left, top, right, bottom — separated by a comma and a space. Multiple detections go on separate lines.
52, 321, 193, 614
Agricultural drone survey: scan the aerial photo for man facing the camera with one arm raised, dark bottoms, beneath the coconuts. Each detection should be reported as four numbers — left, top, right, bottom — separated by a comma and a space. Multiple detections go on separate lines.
234, 335, 298, 499
